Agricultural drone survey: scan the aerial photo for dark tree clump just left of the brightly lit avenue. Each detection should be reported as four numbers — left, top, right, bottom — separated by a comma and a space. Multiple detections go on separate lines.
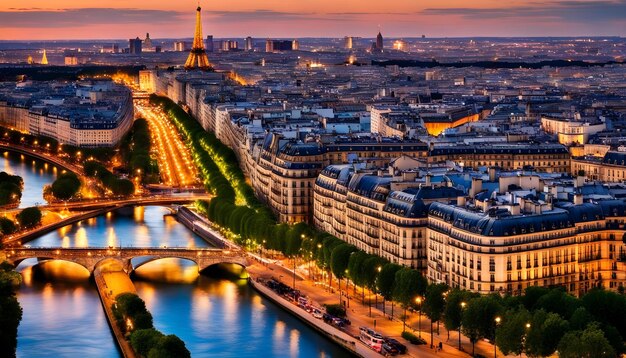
120, 118, 159, 184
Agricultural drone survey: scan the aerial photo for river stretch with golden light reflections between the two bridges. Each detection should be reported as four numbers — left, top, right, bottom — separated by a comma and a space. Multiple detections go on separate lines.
29, 206, 208, 247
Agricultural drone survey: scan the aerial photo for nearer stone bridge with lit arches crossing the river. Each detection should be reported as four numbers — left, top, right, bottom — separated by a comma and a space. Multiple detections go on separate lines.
4, 247, 248, 273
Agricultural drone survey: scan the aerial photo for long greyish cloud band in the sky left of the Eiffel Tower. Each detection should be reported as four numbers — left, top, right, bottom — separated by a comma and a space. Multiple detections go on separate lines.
0, 8, 183, 28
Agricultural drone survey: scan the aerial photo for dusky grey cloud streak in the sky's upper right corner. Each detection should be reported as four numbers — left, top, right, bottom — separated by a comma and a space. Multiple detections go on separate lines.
420, 0, 626, 24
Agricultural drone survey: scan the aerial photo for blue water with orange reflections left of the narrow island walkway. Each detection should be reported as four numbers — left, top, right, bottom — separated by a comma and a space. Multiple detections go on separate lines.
17, 259, 119, 358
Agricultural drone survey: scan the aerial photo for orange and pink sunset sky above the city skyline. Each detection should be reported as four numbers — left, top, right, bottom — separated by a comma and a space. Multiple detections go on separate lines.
0, 0, 626, 40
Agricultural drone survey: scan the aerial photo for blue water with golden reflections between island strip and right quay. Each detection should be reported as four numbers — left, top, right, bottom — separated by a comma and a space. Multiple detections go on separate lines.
134, 259, 349, 357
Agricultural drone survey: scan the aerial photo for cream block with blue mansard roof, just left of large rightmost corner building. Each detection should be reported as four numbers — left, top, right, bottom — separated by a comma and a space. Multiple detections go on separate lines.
313, 162, 464, 271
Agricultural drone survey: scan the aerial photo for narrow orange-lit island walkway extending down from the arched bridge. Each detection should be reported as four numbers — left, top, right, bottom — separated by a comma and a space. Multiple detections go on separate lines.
93, 265, 137, 358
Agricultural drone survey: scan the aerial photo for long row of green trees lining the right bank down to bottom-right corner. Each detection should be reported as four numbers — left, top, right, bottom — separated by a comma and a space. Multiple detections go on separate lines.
153, 97, 626, 357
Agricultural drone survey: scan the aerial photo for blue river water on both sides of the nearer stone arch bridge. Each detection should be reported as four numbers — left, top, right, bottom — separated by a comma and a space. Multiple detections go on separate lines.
17, 201, 348, 357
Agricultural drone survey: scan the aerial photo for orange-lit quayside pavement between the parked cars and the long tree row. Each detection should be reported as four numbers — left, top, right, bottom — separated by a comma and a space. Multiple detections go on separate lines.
247, 260, 503, 357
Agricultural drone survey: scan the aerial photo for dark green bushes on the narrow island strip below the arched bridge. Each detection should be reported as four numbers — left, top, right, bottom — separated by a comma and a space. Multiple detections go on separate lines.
111, 293, 191, 358
